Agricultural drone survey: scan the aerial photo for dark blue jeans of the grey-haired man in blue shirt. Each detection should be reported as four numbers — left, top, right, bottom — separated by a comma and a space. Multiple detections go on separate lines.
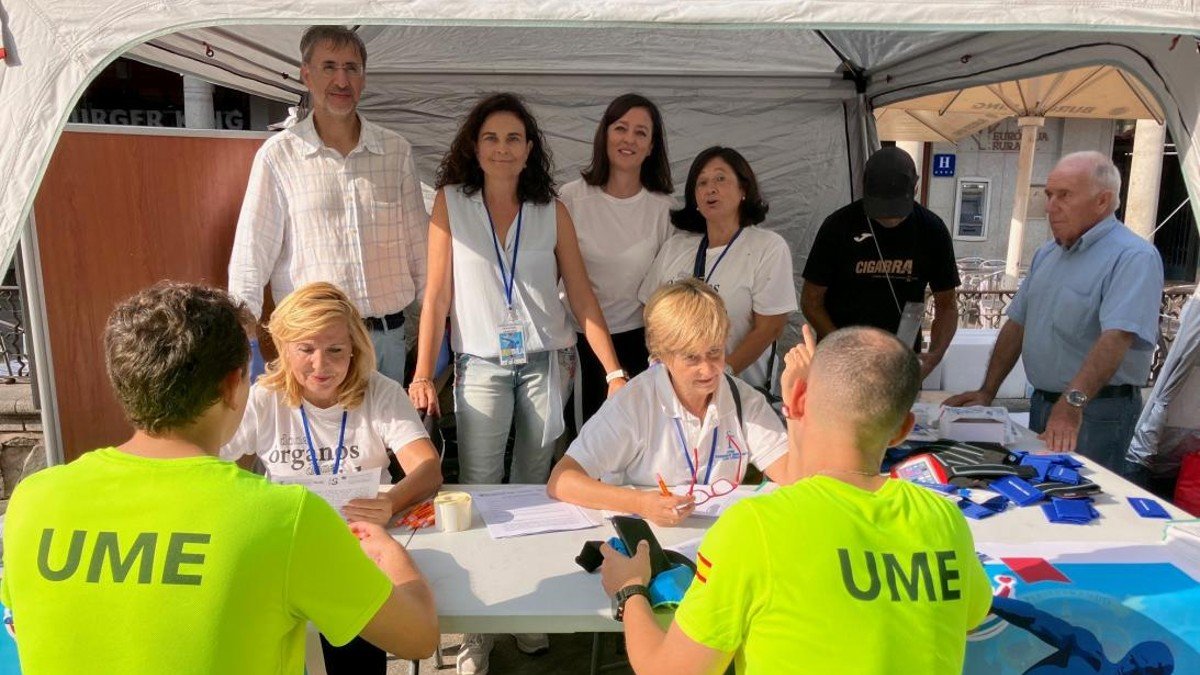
1030, 392, 1145, 486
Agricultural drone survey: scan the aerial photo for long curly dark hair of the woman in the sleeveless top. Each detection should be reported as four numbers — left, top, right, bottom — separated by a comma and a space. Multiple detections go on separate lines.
434, 92, 557, 204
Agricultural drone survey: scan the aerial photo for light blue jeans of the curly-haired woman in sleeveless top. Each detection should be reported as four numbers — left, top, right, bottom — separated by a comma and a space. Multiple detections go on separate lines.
454, 347, 575, 484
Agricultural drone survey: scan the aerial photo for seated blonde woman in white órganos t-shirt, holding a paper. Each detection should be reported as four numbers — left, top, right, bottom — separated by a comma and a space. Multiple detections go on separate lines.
221, 282, 442, 675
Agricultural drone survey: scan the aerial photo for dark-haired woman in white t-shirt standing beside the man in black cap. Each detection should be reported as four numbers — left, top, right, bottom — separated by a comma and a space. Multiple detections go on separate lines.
637, 145, 798, 388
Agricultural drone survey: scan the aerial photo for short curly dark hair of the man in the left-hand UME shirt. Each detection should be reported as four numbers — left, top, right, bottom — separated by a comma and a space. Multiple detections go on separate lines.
104, 281, 253, 434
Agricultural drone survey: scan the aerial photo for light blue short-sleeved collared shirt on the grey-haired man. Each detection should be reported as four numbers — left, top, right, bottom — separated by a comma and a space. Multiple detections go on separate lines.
1008, 215, 1163, 392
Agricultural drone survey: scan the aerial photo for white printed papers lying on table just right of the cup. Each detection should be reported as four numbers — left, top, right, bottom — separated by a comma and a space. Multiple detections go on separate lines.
473, 485, 600, 539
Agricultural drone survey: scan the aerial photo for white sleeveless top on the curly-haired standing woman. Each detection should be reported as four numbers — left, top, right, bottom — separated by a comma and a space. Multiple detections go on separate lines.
444, 185, 575, 358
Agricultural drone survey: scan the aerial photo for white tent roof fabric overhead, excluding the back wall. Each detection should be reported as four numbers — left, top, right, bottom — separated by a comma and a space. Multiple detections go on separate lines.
0, 0, 1200, 270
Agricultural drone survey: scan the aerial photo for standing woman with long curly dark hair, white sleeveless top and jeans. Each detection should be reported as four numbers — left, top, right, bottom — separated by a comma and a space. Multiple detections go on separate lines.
408, 94, 625, 675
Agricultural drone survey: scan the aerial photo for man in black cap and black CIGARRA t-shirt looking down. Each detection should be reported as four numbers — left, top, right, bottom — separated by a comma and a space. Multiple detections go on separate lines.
800, 148, 960, 377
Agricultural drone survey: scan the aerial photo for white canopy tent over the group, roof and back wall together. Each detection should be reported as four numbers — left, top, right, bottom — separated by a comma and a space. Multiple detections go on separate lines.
0, 0, 1200, 461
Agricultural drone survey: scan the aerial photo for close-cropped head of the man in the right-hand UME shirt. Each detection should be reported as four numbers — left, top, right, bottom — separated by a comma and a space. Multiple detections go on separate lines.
810, 325, 920, 449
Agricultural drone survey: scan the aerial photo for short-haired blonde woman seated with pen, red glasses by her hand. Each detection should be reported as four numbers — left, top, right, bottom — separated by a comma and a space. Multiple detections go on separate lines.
546, 279, 799, 526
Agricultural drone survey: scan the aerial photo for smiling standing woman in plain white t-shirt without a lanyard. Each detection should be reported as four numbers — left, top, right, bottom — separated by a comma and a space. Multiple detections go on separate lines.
559, 94, 674, 424
